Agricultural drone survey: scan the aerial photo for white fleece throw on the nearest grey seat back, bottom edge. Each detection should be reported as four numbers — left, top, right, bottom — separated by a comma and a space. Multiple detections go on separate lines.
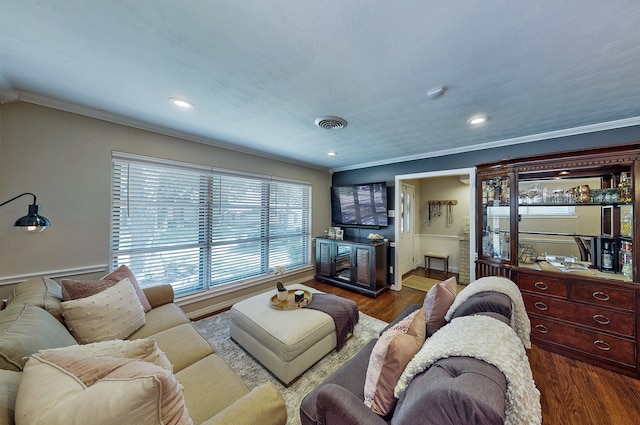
394, 315, 542, 425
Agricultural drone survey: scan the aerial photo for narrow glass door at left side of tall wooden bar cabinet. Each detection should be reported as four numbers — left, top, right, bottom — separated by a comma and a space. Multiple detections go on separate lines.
480, 176, 511, 260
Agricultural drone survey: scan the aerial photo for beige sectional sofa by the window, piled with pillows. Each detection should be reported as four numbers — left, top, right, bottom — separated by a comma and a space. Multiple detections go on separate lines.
0, 277, 287, 425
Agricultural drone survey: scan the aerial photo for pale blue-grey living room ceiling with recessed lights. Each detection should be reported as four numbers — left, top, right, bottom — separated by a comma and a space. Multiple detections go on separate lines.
0, 0, 640, 170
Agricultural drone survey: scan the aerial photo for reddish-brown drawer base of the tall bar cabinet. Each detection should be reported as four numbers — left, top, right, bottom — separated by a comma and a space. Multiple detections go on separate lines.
514, 269, 638, 375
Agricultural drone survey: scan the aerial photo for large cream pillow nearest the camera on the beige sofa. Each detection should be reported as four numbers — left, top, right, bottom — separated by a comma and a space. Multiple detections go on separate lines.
15, 353, 193, 425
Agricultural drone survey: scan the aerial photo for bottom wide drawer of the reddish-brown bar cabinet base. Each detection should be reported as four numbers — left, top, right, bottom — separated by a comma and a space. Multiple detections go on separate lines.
531, 315, 636, 367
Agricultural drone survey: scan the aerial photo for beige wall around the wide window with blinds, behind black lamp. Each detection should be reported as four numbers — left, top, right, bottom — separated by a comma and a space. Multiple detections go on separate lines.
0, 102, 331, 314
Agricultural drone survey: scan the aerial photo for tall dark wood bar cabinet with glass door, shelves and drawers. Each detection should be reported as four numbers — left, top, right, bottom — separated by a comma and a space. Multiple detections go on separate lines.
476, 144, 640, 378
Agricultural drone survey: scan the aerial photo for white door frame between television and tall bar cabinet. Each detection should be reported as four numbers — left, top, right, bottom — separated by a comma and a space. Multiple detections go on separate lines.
391, 167, 478, 291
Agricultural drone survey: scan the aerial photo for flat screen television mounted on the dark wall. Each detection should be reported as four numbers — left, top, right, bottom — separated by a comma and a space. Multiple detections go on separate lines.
331, 182, 389, 227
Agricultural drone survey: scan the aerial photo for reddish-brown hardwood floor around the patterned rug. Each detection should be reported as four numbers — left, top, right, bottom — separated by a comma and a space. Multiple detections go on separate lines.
305, 269, 640, 425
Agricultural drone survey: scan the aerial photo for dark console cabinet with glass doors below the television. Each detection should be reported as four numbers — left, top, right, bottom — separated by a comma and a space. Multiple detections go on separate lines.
315, 237, 389, 297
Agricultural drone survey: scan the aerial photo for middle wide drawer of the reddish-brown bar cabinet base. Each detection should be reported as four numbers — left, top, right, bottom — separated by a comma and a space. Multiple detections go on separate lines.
522, 294, 636, 338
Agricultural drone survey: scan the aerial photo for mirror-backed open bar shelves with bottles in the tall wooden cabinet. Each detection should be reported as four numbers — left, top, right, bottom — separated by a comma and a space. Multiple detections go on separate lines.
518, 168, 633, 281
